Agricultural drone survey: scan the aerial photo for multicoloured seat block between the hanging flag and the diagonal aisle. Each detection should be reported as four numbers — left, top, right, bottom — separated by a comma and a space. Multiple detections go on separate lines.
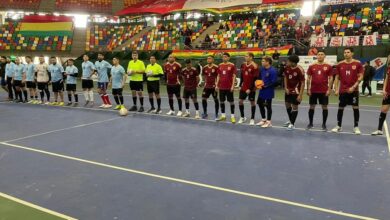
85, 24, 144, 51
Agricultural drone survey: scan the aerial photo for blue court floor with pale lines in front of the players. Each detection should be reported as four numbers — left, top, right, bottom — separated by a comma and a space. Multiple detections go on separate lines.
0, 91, 390, 220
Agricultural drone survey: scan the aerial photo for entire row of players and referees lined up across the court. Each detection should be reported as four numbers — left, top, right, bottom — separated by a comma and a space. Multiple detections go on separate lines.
1, 48, 390, 135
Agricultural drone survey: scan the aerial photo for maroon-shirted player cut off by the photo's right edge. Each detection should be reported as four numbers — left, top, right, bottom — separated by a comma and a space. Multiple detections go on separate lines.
371, 68, 390, 136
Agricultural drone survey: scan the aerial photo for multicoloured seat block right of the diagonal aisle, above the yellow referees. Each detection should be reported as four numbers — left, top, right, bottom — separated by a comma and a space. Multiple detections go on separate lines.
129, 21, 207, 50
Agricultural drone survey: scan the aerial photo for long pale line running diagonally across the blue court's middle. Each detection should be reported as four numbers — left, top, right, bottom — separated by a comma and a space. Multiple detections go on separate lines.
0, 142, 376, 220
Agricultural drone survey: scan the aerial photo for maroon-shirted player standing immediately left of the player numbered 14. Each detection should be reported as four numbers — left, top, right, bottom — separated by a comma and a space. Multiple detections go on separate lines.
306, 50, 333, 131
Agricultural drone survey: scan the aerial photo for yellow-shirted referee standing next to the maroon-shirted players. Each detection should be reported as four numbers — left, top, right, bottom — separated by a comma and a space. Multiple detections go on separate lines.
145, 56, 164, 114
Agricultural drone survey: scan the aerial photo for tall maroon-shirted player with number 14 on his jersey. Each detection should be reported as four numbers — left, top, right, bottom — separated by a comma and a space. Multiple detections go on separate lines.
332, 47, 364, 135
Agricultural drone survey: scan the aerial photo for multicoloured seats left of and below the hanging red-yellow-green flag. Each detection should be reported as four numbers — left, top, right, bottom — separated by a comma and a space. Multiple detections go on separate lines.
0, 21, 73, 51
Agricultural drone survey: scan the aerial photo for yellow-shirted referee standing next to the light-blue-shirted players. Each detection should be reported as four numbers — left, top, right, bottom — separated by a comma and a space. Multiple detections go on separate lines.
127, 51, 145, 112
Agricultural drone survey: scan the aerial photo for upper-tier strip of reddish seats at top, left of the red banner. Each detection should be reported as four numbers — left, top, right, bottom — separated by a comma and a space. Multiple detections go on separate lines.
56, 0, 112, 13
